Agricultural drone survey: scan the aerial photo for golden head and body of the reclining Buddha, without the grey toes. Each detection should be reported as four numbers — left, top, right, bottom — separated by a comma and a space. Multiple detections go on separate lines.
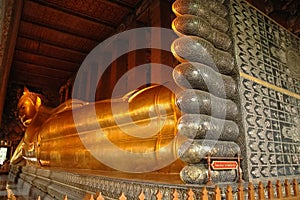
11, 85, 185, 172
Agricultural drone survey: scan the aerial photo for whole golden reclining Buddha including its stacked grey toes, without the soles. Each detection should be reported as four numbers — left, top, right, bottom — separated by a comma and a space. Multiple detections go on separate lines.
11, 0, 240, 184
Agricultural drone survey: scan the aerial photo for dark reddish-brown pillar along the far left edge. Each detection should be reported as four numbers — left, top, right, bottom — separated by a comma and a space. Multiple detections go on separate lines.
0, 0, 23, 123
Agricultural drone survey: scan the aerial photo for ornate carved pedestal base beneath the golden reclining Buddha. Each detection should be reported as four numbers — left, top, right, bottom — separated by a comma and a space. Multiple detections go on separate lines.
9, 166, 241, 200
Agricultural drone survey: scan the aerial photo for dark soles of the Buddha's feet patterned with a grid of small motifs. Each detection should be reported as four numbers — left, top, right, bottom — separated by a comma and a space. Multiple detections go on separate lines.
230, 0, 300, 181
